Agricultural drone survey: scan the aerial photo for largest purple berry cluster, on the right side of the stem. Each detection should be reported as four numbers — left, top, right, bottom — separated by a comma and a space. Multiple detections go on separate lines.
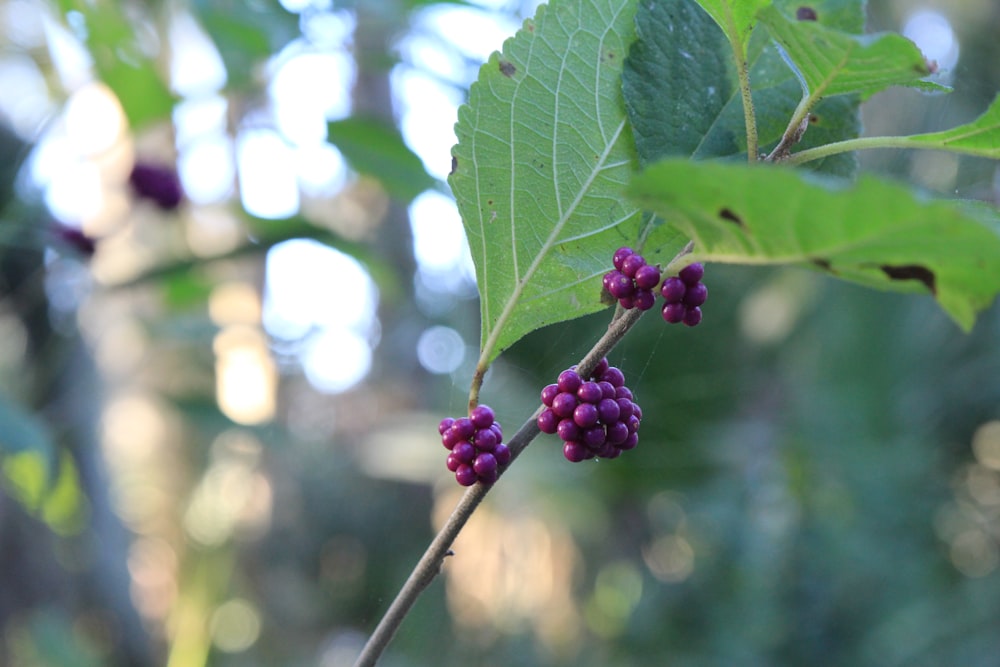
538, 359, 642, 463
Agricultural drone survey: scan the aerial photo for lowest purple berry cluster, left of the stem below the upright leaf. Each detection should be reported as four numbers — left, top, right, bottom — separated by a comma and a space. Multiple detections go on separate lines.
438, 405, 510, 486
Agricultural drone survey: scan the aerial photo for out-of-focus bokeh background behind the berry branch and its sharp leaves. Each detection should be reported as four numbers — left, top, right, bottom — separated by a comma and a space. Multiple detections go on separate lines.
0, 0, 1000, 667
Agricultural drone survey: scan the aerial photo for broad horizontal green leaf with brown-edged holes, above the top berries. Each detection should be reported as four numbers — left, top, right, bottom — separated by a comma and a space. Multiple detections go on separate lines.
629, 159, 1000, 330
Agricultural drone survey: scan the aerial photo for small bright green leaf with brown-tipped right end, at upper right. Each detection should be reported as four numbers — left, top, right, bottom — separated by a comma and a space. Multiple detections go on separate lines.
758, 7, 946, 101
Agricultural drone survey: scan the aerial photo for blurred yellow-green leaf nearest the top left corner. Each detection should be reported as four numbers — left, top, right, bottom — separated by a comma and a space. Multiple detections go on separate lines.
60, 0, 174, 130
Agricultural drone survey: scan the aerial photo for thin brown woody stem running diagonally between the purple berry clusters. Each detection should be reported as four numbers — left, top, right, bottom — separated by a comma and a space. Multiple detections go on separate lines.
354, 276, 660, 667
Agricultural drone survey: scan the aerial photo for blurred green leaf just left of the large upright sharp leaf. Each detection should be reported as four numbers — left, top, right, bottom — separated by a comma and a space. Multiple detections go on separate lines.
327, 116, 435, 201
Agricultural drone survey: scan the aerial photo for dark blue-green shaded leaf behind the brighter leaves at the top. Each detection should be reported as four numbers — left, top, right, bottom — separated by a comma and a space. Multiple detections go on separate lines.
622, 0, 864, 176
